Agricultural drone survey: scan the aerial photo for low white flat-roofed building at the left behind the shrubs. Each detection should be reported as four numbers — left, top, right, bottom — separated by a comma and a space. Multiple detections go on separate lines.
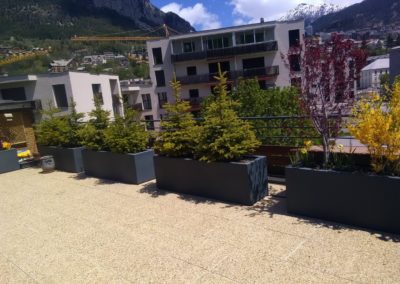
0, 72, 123, 119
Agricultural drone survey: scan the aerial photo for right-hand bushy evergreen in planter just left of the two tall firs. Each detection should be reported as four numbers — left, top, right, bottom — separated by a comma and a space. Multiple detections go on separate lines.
104, 108, 149, 153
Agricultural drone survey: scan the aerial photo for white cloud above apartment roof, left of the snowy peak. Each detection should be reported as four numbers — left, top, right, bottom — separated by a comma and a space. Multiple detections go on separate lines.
228, 0, 362, 23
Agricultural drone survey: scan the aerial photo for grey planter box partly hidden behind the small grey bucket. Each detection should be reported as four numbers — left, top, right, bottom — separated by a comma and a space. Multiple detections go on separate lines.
38, 145, 84, 173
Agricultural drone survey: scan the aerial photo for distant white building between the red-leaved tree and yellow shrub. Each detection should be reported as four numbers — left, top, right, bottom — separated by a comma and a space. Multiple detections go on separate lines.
360, 58, 389, 90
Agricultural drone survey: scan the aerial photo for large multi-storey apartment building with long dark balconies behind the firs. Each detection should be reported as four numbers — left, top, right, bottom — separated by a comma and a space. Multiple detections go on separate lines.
140, 21, 304, 126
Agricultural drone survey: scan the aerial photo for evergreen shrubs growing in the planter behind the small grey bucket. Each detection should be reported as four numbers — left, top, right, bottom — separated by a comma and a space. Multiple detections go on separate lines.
35, 101, 84, 147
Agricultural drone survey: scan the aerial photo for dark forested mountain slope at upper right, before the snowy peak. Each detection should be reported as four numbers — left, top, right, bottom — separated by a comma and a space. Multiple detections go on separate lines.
313, 0, 400, 32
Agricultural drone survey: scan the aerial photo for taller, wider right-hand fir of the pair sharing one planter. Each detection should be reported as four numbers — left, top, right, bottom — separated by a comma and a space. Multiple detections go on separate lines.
195, 66, 260, 162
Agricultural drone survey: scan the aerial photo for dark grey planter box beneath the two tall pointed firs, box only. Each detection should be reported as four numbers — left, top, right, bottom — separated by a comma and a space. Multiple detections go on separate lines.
154, 156, 268, 205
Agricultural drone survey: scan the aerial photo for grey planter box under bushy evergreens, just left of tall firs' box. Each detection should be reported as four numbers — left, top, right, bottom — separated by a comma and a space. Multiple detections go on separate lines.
82, 149, 154, 184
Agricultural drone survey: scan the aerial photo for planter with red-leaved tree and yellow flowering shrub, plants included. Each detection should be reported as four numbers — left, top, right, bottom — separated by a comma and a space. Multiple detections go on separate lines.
286, 35, 400, 233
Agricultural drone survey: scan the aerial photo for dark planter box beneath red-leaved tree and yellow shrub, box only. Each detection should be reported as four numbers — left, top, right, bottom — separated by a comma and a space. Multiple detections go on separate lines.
286, 167, 400, 233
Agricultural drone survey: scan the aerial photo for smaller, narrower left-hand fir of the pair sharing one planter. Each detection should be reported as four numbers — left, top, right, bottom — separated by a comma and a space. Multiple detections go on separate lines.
154, 77, 199, 157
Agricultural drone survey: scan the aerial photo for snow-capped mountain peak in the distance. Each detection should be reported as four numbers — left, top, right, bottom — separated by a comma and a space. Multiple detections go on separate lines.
280, 3, 342, 26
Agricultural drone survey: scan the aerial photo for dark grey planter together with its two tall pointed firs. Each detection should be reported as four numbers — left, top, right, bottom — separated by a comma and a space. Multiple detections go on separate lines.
154, 66, 267, 205
